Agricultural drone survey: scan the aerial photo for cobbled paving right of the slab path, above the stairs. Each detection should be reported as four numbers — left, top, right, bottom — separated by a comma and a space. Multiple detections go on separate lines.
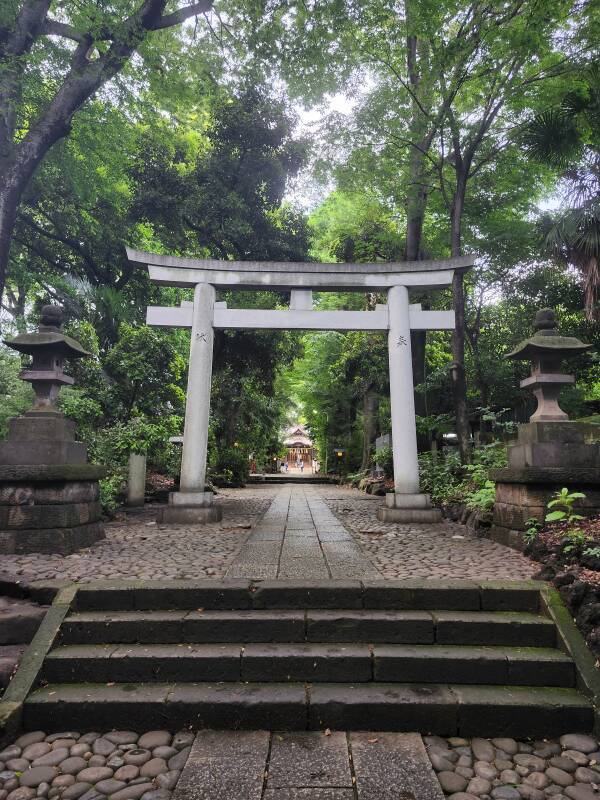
318, 486, 539, 580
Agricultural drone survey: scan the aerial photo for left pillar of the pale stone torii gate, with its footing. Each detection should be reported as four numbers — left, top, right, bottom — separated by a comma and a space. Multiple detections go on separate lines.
159, 283, 222, 523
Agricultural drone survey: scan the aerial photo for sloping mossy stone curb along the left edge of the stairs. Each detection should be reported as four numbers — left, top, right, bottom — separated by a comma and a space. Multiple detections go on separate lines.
0, 585, 77, 746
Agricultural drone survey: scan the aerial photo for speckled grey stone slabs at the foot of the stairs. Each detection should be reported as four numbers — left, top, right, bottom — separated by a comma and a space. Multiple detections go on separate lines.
171, 731, 443, 800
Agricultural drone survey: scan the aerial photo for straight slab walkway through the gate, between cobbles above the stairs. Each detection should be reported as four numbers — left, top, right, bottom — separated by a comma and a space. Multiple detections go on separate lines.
226, 484, 378, 580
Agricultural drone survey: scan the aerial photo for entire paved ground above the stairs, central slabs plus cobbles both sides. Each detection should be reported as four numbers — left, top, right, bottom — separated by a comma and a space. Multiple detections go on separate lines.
2, 484, 539, 582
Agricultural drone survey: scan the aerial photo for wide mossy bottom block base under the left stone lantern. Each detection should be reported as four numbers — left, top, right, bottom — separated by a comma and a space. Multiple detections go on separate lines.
0, 464, 106, 555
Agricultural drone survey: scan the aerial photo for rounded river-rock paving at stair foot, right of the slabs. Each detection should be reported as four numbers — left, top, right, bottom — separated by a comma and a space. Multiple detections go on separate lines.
425, 733, 600, 800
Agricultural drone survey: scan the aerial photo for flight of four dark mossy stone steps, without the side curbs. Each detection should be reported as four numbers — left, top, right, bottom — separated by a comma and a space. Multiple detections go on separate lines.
16, 580, 594, 736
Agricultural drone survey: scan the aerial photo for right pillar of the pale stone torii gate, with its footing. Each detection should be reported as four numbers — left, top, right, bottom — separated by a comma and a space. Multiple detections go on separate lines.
377, 286, 441, 522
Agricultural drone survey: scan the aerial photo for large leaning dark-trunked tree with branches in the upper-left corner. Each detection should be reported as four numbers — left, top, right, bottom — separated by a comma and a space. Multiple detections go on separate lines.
0, 0, 212, 316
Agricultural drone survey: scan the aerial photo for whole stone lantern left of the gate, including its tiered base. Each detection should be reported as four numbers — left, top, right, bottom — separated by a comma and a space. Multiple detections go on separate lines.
0, 306, 106, 554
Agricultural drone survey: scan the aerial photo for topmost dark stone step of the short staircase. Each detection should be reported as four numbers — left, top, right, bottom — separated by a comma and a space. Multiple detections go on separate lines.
76, 580, 542, 612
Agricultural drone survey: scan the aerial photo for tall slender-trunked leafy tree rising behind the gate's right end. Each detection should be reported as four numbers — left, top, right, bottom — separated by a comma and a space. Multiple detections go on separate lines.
274, 0, 586, 461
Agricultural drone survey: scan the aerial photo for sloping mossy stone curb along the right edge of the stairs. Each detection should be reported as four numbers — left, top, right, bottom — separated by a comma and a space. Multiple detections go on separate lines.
541, 584, 600, 735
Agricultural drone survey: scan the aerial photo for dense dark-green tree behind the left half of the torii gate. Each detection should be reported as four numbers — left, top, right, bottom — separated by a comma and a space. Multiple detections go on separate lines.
131, 85, 308, 458
